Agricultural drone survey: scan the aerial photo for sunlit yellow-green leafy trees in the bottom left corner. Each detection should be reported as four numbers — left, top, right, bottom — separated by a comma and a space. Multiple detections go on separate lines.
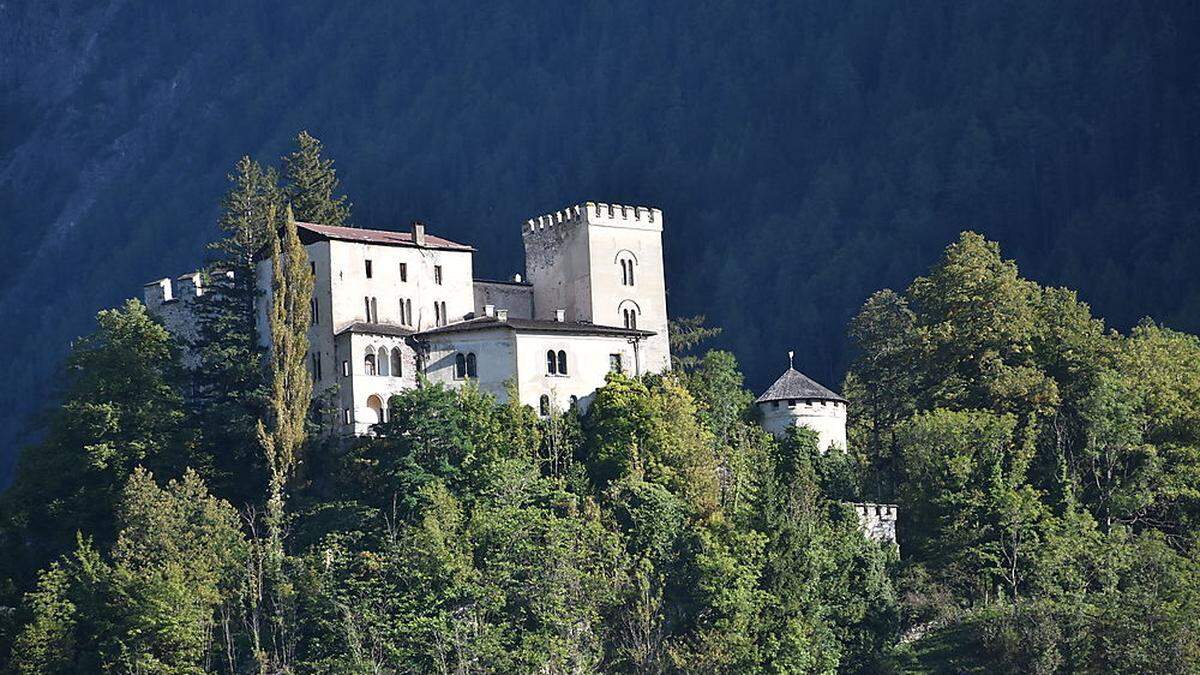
12, 470, 246, 674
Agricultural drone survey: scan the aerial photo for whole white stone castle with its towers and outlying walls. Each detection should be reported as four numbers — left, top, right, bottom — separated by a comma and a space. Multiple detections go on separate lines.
144, 202, 895, 540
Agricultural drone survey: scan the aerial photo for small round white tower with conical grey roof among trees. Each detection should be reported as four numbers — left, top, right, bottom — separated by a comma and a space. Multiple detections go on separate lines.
755, 352, 847, 453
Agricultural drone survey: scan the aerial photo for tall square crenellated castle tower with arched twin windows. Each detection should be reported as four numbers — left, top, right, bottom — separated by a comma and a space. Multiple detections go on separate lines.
522, 202, 671, 372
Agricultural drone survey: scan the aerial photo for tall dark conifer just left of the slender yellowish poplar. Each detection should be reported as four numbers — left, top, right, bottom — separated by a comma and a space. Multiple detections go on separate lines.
190, 156, 283, 504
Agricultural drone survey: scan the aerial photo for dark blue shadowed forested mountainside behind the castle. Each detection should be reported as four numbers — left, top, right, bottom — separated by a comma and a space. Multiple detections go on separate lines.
0, 0, 1200, 474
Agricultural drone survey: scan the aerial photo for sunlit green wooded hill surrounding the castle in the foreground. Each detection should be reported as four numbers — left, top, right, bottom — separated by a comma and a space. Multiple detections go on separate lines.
0, 169, 1200, 675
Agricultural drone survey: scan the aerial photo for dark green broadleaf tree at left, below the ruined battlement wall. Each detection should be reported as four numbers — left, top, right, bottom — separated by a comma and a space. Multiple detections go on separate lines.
0, 300, 192, 588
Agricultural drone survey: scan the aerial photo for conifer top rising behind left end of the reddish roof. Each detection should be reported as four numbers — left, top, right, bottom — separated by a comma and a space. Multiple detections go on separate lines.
283, 131, 350, 227
